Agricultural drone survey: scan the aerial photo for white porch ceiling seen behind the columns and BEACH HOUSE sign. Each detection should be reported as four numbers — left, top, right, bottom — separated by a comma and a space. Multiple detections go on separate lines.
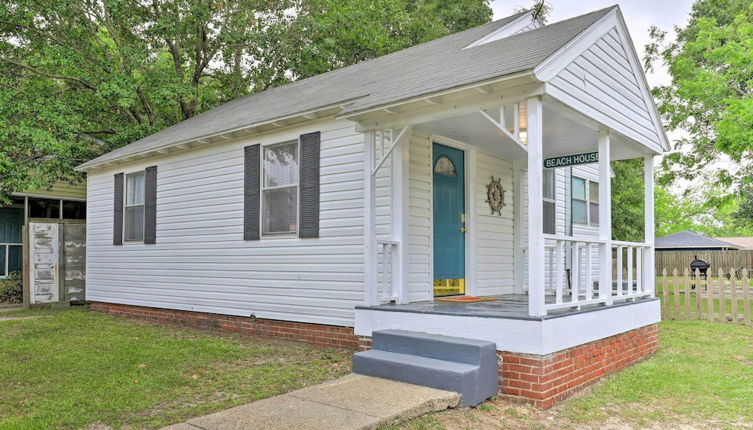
414, 97, 648, 161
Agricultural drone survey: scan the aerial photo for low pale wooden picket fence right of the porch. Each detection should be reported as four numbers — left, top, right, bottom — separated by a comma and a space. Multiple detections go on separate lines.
656, 268, 753, 326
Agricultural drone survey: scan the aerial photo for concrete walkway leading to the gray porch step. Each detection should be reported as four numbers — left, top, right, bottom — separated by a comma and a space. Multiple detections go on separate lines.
162, 374, 460, 430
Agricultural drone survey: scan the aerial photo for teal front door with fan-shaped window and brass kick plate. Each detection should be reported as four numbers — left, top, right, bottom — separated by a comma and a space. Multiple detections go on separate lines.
432, 143, 465, 296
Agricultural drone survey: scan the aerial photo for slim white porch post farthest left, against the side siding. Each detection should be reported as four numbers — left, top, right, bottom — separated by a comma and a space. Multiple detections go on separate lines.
363, 131, 379, 306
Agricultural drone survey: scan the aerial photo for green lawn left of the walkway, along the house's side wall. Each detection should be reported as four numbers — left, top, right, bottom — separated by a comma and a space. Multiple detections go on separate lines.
0, 308, 350, 429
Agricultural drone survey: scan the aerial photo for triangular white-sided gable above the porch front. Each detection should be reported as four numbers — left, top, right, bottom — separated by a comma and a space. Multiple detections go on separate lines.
534, 7, 669, 153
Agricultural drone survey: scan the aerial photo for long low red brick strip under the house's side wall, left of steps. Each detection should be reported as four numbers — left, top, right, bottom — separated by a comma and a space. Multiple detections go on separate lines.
91, 302, 358, 349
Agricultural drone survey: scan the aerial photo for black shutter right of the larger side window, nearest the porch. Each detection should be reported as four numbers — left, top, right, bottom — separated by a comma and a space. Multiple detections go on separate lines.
298, 131, 321, 237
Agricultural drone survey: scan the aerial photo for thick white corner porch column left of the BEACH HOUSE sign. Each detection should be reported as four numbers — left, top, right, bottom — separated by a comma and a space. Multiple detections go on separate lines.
527, 97, 546, 316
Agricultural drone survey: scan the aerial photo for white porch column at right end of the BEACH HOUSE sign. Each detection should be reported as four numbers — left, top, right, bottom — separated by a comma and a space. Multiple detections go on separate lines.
600, 128, 612, 304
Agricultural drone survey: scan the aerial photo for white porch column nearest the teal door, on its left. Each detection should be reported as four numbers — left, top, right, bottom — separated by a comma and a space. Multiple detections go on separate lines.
392, 128, 411, 303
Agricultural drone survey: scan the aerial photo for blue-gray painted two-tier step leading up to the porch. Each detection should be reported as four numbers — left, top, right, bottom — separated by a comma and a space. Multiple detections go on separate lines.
353, 330, 499, 406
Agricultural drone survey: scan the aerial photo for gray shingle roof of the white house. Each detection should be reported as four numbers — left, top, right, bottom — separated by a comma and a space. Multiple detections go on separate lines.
79, 6, 614, 168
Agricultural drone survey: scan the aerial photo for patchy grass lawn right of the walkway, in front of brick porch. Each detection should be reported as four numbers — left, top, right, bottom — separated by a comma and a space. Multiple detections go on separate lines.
391, 321, 753, 430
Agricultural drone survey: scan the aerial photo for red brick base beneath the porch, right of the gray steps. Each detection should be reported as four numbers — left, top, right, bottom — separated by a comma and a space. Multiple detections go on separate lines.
497, 324, 659, 408
